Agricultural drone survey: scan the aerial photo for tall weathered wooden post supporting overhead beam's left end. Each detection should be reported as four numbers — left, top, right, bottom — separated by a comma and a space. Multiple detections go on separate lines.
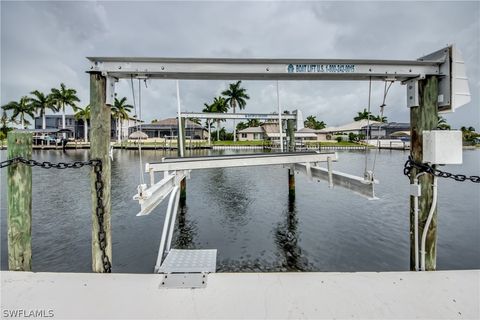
90, 72, 112, 272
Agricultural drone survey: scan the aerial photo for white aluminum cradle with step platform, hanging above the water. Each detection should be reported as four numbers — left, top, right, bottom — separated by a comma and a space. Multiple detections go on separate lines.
133, 152, 378, 288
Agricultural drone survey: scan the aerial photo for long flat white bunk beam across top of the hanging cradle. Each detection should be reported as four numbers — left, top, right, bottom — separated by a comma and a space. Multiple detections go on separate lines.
145, 152, 337, 172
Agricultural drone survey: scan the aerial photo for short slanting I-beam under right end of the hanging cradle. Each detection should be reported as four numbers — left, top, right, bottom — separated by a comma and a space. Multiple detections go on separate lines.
294, 163, 378, 199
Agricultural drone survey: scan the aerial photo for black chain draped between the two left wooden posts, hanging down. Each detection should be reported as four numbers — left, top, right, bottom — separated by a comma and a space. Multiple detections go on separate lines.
0, 157, 112, 273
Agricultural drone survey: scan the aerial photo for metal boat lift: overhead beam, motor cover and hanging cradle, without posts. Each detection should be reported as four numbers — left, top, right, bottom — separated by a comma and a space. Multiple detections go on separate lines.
88, 46, 470, 287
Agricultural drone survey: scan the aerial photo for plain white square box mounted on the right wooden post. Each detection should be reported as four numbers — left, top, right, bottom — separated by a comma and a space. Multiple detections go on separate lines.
423, 130, 462, 164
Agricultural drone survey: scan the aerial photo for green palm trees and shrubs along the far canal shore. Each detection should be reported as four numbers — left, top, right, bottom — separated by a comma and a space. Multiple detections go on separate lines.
0, 80, 480, 142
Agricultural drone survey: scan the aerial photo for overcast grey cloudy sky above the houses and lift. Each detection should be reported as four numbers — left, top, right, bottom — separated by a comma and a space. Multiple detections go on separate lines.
1, 1, 480, 129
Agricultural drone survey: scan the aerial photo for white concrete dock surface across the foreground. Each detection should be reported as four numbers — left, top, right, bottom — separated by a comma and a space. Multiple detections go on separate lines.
0, 270, 480, 319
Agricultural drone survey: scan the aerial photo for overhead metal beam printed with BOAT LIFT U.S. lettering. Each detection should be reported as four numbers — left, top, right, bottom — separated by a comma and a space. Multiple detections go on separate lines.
88, 57, 444, 81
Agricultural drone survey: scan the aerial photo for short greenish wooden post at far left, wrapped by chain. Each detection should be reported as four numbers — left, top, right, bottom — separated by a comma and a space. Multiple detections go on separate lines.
7, 131, 32, 271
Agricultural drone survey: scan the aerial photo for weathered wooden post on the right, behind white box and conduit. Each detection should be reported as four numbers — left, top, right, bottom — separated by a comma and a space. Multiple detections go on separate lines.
410, 76, 438, 270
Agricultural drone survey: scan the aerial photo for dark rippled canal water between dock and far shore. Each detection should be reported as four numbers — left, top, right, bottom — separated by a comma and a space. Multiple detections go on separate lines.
0, 150, 480, 273
